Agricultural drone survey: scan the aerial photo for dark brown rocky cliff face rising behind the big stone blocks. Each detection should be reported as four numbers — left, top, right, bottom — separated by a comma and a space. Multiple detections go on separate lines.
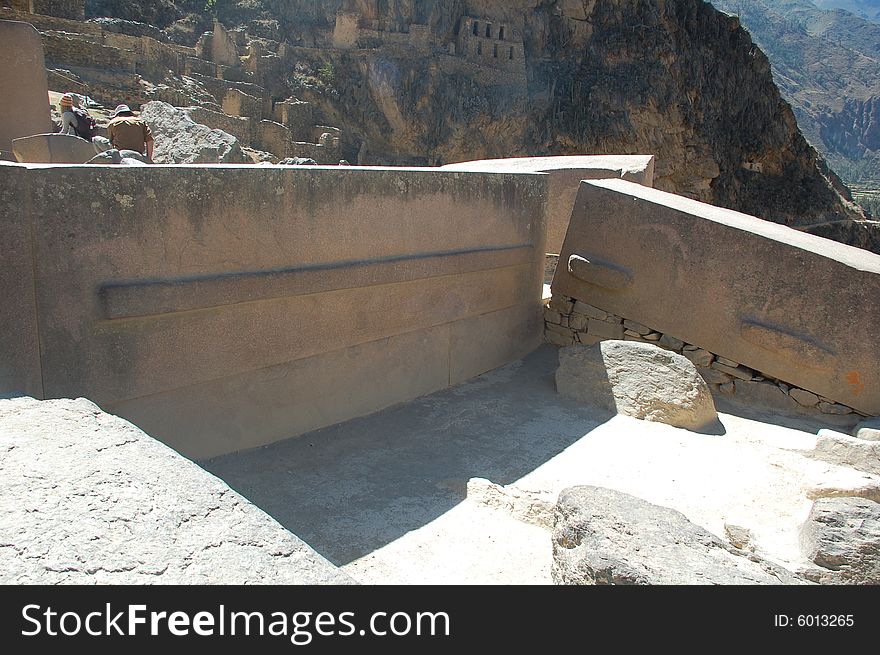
81, 0, 880, 250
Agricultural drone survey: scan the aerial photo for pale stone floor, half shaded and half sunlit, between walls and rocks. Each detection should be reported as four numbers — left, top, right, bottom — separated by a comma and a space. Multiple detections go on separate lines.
201, 346, 880, 584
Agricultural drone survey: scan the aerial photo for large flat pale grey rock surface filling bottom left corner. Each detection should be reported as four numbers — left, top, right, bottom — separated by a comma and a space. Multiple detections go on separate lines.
0, 398, 351, 584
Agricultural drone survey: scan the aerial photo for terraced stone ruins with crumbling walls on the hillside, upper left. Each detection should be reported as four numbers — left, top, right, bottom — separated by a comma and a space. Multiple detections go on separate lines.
0, 0, 527, 164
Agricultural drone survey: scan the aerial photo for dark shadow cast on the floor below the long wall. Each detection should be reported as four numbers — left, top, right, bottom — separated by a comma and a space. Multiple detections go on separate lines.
200, 346, 610, 566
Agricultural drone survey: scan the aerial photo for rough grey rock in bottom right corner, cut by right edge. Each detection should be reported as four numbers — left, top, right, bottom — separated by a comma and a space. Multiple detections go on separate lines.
801, 498, 880, 584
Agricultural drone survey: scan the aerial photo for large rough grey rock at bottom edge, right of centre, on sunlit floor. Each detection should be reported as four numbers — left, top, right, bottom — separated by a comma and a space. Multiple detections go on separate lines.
552, 486, 803, 585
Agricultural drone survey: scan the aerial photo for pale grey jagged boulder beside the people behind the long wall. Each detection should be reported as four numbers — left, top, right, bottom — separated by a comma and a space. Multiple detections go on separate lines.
141, 100, 250, 164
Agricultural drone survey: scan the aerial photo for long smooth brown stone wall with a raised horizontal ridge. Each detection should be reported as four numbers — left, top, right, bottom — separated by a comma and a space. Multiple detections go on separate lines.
0, 164, 546, 457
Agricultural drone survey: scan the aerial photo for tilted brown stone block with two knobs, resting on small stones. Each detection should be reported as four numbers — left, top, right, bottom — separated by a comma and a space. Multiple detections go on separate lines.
547, 180, 880, 415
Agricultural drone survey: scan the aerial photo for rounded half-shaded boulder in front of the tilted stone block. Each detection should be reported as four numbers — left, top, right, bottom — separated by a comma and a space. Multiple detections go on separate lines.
556, 341, 718, 430
